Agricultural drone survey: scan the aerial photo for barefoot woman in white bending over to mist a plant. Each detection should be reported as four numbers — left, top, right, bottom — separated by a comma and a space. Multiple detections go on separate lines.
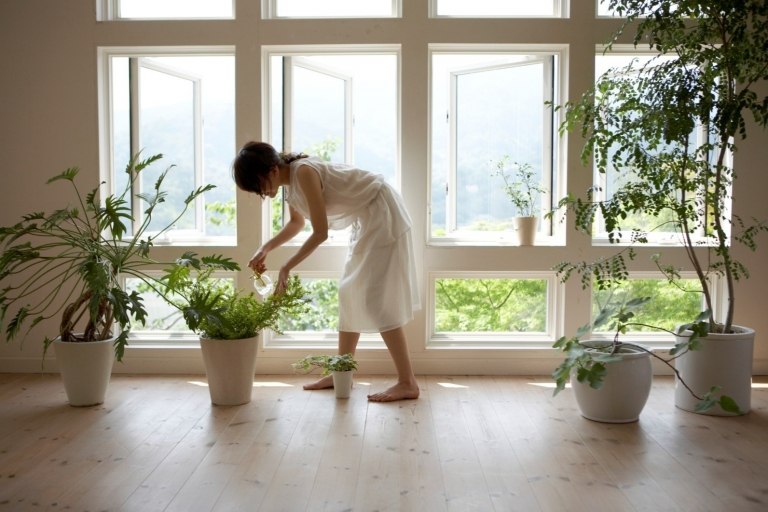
233, 142, 419, 402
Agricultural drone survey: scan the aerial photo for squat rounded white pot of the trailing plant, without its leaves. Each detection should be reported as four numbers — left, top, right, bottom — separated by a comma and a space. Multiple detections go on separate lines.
571, 342, 653, 423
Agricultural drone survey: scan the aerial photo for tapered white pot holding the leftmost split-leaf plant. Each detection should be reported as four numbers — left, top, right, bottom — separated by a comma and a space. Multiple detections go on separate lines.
53, 338, 115, 407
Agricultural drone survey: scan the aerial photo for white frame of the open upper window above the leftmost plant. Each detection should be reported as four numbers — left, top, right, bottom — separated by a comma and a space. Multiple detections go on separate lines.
97, 46, 236, 246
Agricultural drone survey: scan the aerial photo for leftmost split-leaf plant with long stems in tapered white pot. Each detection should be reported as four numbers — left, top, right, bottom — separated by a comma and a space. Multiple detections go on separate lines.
0, 154, 213, 406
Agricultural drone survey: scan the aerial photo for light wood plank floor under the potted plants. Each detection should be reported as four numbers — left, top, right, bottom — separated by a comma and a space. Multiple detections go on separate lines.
0, 374, 768, 512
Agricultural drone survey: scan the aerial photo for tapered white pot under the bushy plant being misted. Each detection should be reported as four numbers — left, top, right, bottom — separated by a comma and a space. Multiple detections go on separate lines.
200, 336, 259, 405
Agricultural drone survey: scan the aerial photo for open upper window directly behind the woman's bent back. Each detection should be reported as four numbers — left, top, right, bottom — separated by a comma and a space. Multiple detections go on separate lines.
264, 47, 399, 241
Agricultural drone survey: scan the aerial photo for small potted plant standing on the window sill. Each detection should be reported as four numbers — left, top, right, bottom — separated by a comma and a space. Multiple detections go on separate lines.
495, 155, 546, 245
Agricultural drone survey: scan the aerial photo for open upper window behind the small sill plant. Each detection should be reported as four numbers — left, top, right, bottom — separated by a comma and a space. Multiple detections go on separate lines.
431, 49, 560, 243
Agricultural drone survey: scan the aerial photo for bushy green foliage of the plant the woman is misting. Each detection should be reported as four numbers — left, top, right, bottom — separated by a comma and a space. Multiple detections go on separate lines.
162, 252, 307, 340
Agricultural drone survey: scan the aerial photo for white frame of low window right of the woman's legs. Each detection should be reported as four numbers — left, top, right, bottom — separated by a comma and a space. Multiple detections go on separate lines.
426, 271, 565, 349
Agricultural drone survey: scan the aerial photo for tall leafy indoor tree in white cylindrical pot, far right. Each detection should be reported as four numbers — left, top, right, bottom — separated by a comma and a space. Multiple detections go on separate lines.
556, 0, 768, 414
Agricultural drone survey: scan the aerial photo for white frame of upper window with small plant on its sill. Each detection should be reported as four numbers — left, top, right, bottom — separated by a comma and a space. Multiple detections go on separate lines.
427, 44, 568, 246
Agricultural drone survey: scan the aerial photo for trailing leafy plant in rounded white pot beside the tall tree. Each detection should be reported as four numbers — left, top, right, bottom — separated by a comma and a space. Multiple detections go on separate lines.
552, 297, 740, 423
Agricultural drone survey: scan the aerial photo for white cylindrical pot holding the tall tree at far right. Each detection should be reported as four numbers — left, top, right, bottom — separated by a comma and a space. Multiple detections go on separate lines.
675, 326, 755, 416
